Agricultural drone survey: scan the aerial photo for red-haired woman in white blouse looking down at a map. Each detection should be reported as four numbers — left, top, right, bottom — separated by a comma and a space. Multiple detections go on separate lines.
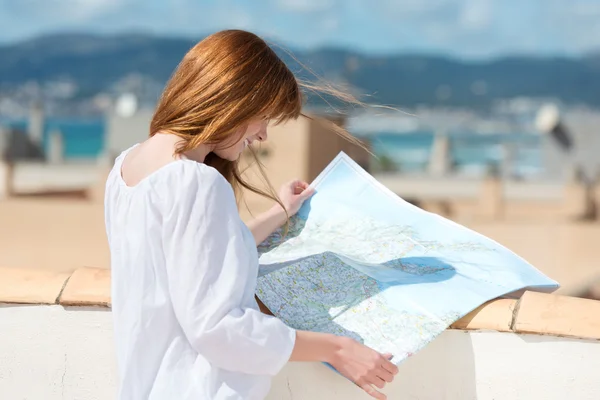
105, 31, 397, 400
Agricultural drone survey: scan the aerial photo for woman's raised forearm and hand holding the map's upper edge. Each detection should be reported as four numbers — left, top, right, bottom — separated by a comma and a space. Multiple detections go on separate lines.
248, 180, 314, 246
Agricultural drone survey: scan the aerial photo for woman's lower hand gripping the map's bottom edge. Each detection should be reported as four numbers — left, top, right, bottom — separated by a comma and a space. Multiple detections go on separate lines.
328, 337, 398, 399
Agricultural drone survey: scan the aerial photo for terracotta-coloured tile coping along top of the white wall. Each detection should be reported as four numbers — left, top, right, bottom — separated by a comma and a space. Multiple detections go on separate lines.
0, 267, 600, 340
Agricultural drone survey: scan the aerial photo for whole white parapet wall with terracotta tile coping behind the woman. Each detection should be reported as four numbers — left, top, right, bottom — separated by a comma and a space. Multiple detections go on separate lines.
0, 268, 600, 400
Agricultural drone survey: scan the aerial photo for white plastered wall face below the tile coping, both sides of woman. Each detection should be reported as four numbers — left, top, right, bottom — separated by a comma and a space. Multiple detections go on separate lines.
0, 305, 600, 400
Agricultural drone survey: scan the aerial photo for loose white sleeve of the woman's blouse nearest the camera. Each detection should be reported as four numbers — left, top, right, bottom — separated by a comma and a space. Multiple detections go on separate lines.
163, 165, 296, 375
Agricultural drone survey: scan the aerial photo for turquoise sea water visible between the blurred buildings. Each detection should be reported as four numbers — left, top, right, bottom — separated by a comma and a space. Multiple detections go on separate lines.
3, 118, 542, 176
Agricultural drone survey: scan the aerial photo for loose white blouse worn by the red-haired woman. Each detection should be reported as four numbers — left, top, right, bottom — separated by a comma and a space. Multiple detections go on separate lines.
105, 148, 296, 400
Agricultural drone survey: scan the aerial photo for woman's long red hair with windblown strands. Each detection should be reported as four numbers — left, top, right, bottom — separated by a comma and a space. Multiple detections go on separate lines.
150, 30, 366, 209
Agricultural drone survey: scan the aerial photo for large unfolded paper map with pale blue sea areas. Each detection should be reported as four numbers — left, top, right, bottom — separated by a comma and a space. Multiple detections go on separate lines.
257, 153, 558, 364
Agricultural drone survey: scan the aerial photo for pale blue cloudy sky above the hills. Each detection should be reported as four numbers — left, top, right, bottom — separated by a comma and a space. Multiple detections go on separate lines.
0, 0, 600, 59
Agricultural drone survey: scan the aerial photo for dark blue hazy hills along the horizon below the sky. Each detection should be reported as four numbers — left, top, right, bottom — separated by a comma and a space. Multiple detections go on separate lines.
0, 30, 600, 112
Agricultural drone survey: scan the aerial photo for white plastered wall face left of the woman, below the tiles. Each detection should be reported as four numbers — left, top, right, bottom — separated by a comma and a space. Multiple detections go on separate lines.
0, 306, 116, 400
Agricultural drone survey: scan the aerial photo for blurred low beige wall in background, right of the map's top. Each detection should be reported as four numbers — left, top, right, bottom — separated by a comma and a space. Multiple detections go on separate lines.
375, 173, 600, 222
